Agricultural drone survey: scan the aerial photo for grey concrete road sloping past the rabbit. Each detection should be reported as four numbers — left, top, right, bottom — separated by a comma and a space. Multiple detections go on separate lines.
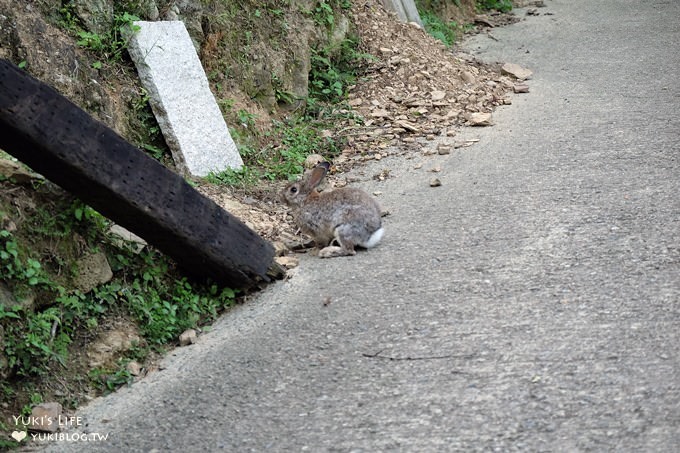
49, 0, 680, 452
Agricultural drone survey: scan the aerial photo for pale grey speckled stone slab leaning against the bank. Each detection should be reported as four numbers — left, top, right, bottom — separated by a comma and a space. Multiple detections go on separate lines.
128, 21, 243, 176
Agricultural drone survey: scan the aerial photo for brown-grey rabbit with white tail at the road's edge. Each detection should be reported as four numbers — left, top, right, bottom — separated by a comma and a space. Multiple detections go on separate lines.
280, 162, 384, 258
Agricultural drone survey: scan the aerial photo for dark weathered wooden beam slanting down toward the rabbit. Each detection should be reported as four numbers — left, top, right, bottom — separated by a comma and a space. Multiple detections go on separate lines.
0, 59, 274, 287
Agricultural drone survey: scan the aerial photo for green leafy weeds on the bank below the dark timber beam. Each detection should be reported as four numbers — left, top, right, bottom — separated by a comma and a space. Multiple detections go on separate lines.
0, 201, 235, 382
